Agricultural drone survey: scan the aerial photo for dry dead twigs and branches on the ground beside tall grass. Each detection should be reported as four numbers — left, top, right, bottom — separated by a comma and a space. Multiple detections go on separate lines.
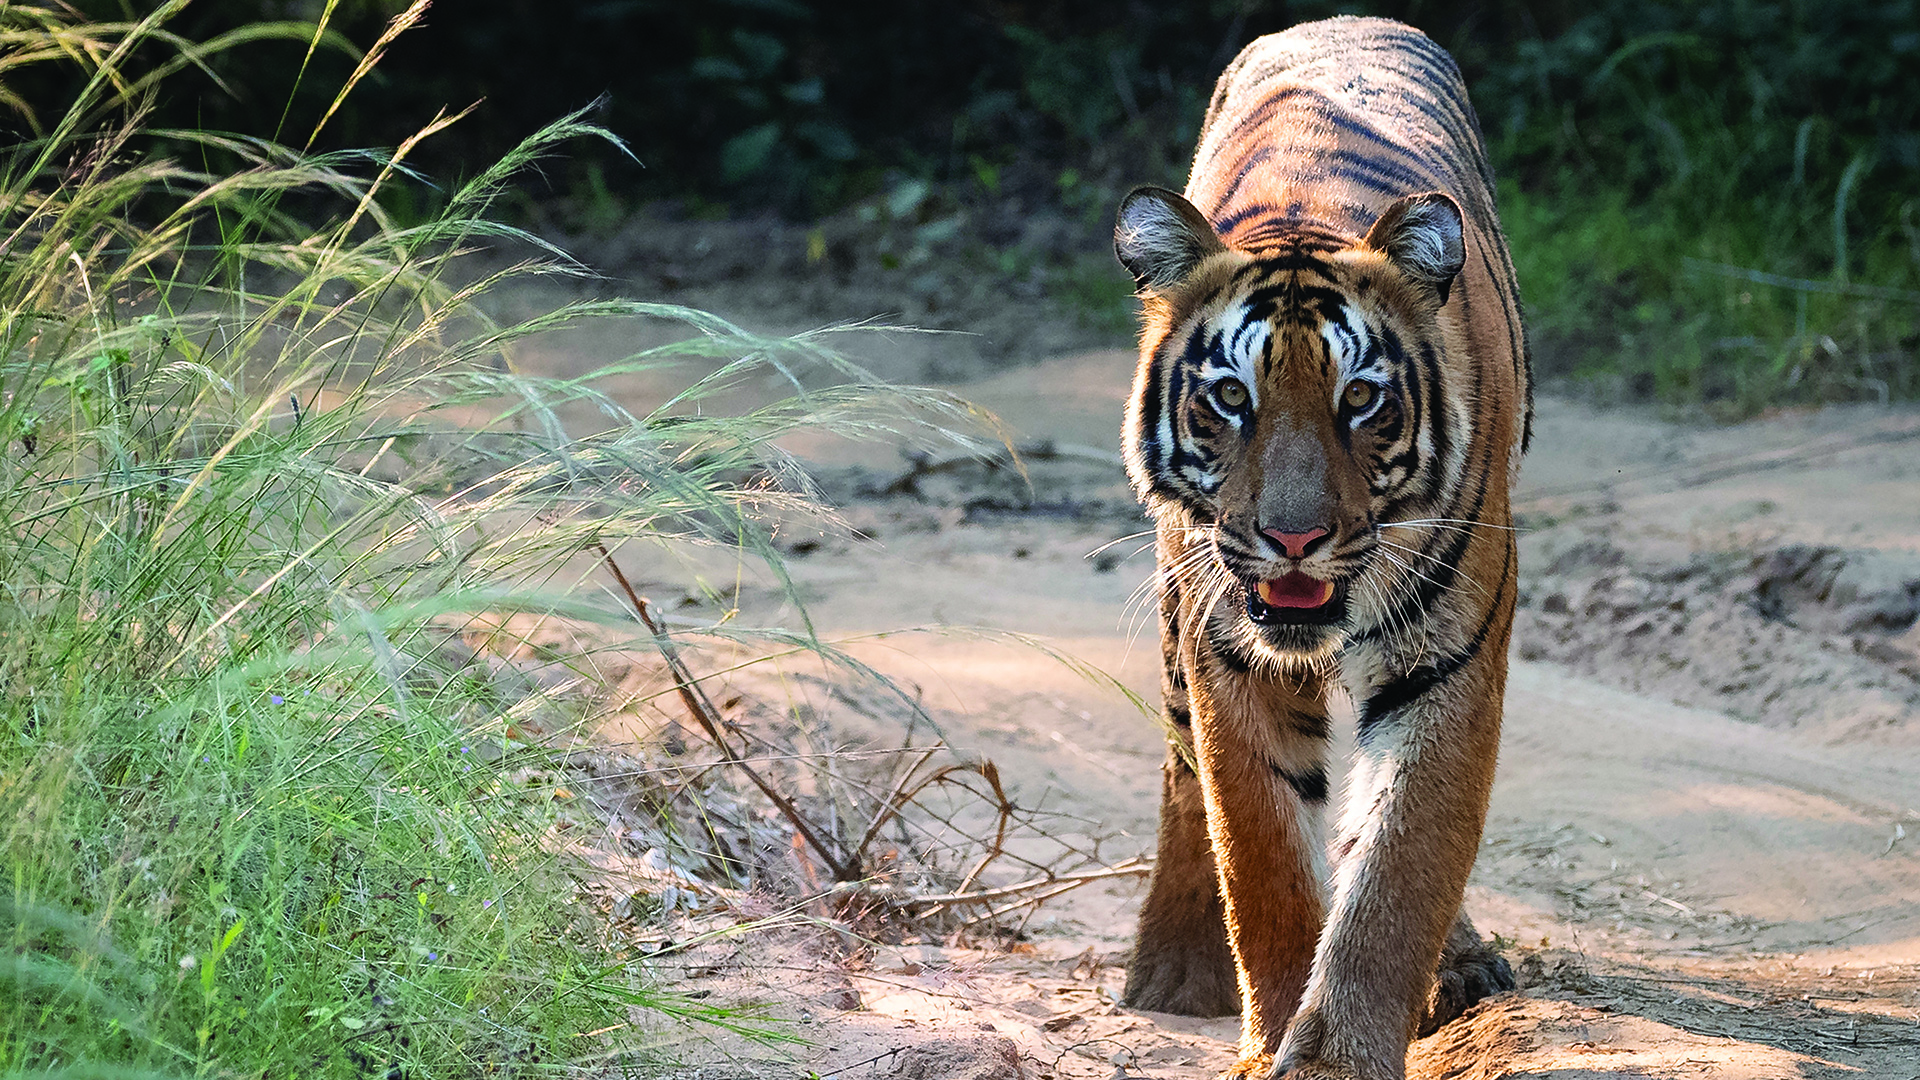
526, 544, 1148, 934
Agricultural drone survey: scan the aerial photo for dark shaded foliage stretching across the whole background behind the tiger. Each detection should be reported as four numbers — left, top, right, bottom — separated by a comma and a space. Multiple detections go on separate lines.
30, 0, 1920, 411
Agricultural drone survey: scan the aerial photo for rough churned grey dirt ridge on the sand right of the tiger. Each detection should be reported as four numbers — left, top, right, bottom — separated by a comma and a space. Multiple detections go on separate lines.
1515, 530, 1920, 742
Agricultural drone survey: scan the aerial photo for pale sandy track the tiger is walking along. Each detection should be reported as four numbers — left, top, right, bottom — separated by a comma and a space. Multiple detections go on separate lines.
491, 253, 1920, 1080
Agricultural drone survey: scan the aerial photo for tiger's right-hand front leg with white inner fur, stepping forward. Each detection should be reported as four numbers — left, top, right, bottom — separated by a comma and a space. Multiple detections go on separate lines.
1269, 634, 1505, 1080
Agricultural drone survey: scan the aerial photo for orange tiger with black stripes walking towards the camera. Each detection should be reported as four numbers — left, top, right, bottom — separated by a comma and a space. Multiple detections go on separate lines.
1114, 17, 1532, 1080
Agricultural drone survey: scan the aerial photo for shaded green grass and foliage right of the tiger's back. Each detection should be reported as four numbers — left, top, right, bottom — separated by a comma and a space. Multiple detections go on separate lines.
1473, 0, 1920, 407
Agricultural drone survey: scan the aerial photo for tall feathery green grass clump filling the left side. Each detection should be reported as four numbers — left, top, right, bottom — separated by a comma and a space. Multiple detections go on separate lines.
0, 6, 967, 1076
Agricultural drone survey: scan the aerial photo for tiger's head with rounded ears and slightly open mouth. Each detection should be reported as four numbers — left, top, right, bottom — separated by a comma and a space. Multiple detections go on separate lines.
1114, 188, 1469, 657
